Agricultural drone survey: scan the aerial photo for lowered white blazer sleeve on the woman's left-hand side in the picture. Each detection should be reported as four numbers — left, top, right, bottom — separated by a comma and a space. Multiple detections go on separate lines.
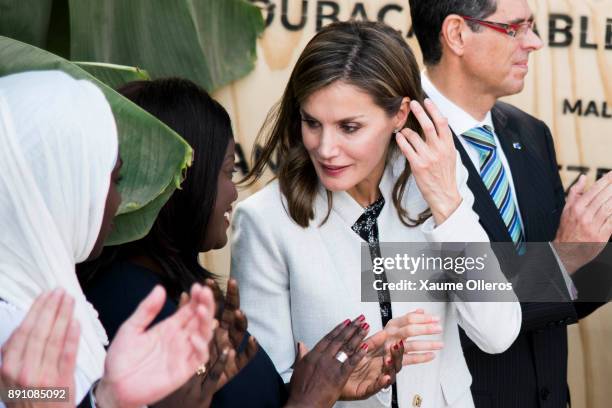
231, 205, 295, 382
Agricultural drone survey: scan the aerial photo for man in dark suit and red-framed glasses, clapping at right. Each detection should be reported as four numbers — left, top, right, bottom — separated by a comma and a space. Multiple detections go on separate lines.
410, 0, 612, 408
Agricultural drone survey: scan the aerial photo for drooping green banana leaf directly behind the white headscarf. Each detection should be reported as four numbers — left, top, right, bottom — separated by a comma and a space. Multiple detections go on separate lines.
0, 37, 192, 244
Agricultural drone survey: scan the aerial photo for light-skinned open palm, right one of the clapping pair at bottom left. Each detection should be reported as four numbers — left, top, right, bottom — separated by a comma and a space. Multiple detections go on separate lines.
96, 284, 215, 408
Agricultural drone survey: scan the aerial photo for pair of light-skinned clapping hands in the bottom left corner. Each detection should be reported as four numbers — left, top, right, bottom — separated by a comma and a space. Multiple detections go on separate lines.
1, 285, 214, 408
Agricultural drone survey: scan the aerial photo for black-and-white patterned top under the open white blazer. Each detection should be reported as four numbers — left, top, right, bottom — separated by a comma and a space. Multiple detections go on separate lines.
351, 195, 398, 408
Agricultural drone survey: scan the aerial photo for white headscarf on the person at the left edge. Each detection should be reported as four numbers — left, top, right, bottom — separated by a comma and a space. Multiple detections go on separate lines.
0, 71, 118, 382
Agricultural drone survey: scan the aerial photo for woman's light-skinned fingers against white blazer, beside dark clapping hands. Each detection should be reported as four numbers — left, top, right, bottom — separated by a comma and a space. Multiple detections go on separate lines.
384, 309, 444, 365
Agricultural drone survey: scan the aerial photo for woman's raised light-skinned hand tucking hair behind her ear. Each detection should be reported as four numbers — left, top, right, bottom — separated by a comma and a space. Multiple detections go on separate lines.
395, 99, 461, 225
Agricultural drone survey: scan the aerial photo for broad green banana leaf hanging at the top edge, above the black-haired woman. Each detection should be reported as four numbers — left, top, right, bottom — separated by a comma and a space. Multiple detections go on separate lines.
69, 0, 264, 91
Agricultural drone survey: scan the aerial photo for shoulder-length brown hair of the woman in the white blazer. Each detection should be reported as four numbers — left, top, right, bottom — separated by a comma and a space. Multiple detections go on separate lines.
240, 21, 431, 227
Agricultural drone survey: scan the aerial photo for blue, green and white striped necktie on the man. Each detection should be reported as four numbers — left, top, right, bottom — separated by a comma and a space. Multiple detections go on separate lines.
462, 125, 525, 252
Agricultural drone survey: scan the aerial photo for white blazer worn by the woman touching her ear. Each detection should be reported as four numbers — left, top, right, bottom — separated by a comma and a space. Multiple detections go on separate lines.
231, 157, 521, 408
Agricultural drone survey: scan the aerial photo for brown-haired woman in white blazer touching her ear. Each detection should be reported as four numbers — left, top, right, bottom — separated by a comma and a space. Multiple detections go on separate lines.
231, 22, 521, 408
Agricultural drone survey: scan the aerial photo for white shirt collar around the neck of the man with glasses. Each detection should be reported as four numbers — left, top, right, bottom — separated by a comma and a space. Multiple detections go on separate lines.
421, 71, 495, 135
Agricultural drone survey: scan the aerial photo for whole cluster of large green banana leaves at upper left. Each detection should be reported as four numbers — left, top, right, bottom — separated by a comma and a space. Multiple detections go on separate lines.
0, 0, 264, 245
